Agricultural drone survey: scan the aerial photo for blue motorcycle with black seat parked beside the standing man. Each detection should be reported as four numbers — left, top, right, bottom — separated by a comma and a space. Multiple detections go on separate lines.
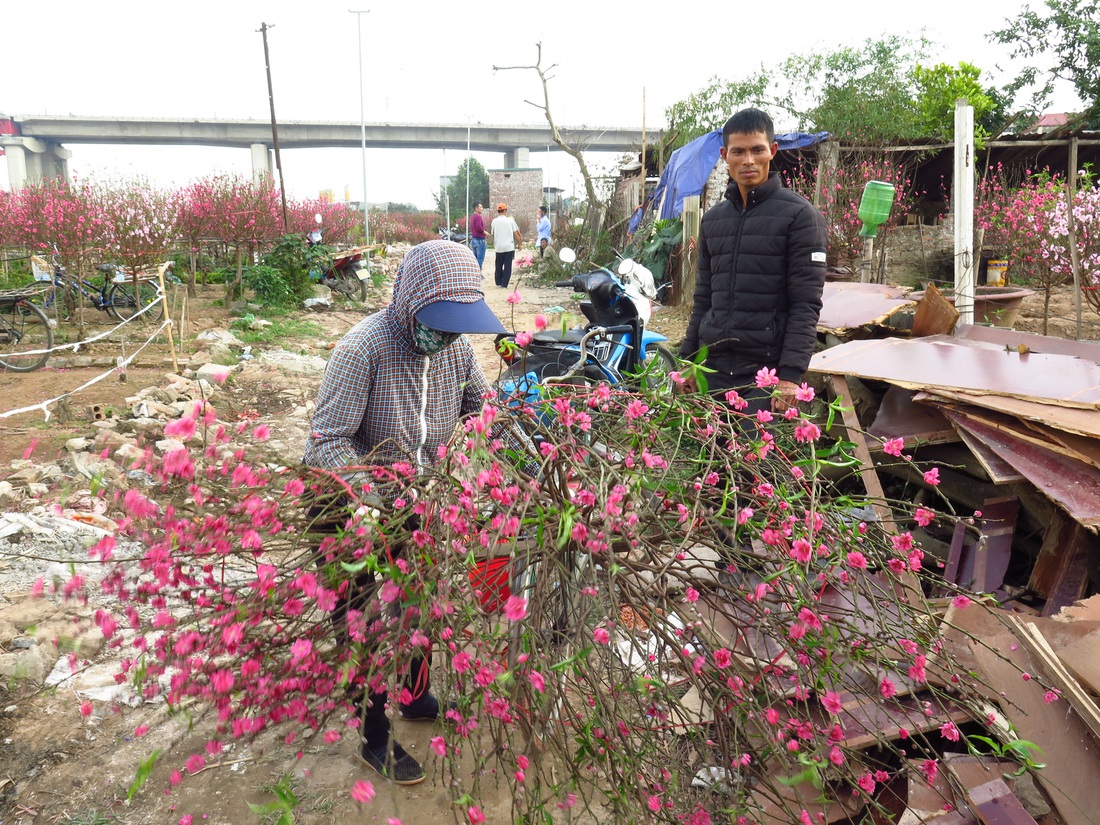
496, 248, 677, 411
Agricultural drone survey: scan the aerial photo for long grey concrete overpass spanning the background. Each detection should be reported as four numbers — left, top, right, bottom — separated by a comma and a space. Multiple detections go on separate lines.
0, 114, 642, 189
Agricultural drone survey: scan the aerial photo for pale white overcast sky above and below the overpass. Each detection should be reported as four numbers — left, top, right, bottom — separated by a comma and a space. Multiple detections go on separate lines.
0, 0, 1076, 208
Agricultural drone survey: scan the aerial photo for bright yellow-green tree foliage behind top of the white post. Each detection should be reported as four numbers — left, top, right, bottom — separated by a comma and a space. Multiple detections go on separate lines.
914, 63, 1004, 145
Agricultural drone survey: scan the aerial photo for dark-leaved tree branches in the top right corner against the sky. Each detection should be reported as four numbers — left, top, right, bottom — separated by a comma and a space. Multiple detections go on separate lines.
989, 0, 1100, 128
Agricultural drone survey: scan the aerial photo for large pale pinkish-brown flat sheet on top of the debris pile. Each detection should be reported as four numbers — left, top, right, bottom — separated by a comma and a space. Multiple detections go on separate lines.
810, 336, 1100, 409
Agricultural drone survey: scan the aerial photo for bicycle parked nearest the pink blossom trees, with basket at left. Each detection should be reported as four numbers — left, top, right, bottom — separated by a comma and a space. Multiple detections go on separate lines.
31, 256, 172, 321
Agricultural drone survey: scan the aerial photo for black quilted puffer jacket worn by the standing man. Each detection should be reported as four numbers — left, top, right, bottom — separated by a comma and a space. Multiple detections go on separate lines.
680, 172, 825, 383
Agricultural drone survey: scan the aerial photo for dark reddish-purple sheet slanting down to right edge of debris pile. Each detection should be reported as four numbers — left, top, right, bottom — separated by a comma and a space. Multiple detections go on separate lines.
945, 410, 1100, 528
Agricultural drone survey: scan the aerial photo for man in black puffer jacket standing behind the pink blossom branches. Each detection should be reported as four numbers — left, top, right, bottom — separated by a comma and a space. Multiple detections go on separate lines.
680, 109, 825, 413
